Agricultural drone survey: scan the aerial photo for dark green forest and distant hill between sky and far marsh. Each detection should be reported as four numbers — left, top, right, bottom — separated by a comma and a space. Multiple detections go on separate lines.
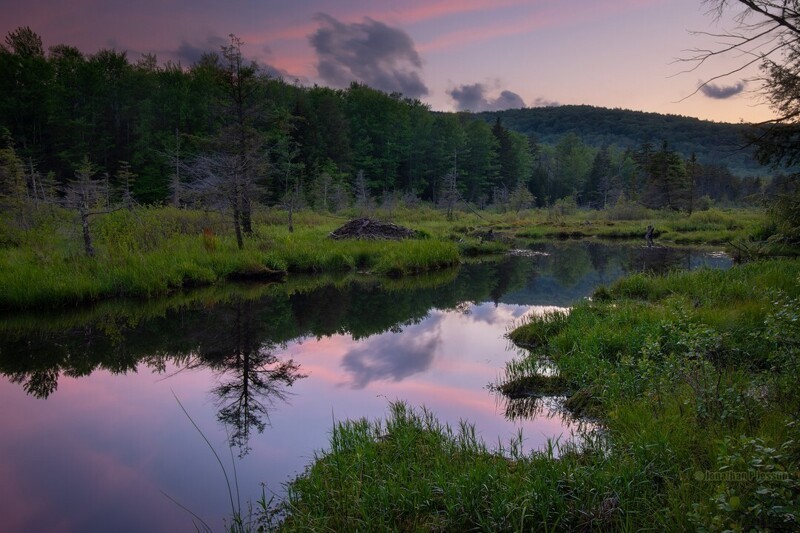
0, 28, 780, 211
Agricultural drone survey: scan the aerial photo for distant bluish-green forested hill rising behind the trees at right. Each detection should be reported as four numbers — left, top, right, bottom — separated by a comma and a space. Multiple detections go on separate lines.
477, 105, 765, 176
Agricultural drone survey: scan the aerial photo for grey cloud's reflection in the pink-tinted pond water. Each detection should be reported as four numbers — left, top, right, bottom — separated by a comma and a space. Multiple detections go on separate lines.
342, 326, 441, 389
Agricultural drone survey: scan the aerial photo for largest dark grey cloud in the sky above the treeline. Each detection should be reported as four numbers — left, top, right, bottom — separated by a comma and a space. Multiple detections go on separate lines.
309, 14, 428, 98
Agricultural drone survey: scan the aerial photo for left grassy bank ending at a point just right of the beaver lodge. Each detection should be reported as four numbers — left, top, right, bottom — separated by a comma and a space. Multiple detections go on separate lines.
0, 208, 460, 309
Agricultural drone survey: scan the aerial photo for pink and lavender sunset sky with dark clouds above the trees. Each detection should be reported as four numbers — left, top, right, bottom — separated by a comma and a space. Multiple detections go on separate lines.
0, 0, 772, 122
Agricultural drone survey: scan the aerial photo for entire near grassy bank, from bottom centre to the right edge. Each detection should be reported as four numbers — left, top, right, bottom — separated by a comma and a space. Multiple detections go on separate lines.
272, 260, 800, 531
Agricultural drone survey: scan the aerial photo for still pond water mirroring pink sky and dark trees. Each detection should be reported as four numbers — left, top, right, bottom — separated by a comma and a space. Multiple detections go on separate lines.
0, 241, 730, 532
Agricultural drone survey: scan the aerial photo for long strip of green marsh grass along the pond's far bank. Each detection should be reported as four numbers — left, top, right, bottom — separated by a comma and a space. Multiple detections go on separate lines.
0, 206, 763, 309
